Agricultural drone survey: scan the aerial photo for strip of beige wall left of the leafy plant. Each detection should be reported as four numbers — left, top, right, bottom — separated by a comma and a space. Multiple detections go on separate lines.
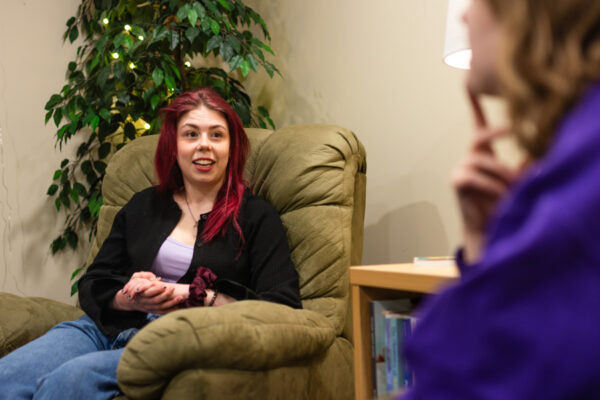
0, 0, 82, 302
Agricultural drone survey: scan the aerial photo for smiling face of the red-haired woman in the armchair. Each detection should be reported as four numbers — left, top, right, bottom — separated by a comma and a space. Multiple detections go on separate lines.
177, 106, 229, 191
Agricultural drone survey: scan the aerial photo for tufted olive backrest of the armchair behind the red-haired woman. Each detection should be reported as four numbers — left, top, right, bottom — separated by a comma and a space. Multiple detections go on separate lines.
88, 125, 366, 337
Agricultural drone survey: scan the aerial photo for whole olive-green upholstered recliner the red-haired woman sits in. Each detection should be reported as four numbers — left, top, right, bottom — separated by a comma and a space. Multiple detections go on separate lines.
0, 125, 366, 400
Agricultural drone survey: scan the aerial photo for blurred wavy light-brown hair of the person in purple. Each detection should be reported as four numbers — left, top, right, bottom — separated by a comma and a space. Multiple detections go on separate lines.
486, 0, 600, 158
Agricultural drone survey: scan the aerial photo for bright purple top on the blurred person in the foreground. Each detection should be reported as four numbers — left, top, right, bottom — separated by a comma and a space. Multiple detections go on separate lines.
402, 84, 600, 400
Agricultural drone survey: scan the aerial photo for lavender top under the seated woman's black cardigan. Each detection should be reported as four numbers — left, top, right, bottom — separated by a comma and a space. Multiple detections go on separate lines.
152, 236, 194, 282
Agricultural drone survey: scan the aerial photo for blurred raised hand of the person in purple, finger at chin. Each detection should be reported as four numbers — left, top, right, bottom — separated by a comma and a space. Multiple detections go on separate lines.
452, 93, 517, 263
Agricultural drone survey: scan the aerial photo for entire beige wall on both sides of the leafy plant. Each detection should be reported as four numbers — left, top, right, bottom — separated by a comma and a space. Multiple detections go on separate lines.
0, 0, 510, 302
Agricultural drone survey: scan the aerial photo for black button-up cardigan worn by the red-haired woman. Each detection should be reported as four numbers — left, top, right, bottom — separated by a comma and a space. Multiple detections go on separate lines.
78, 187, 302, 336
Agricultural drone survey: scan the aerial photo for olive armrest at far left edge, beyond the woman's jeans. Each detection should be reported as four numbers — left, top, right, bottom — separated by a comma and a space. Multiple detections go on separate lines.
0, 293, 83, 357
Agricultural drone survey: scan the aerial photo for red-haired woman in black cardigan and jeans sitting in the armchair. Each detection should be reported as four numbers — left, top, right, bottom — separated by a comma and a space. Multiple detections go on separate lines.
0, 88, 302, 400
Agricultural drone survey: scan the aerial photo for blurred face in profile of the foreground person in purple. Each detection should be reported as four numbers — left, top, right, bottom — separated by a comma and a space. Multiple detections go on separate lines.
463, 0, 501, 95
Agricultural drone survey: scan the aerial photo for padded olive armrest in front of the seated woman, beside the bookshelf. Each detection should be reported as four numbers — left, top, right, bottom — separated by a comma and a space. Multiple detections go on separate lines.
117, 300, 336, 398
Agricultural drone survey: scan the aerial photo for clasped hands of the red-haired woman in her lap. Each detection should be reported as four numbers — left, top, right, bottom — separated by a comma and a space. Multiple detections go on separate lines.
111, 271, 190, 314
